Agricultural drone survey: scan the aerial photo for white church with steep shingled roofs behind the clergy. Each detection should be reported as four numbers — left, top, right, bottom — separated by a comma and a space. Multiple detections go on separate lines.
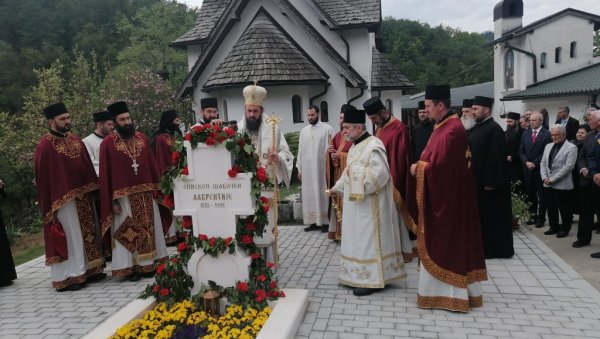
172, 0, 414, 132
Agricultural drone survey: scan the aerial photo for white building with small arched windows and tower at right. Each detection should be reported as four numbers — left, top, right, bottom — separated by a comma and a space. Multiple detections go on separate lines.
490, 0, 600, 124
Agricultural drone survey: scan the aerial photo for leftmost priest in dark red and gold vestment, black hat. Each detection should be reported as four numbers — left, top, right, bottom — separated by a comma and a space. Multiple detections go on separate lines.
34, 103, 106, 292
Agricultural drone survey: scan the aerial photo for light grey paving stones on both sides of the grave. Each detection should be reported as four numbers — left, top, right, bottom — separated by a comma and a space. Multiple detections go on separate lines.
0, 226, 600, 339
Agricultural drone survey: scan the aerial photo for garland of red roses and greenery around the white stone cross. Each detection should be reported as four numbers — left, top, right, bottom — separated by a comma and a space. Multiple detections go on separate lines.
147, 124, 285, 308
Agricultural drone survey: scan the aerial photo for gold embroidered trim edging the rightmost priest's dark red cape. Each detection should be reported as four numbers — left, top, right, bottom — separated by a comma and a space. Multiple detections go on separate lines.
416, 160, 487, 288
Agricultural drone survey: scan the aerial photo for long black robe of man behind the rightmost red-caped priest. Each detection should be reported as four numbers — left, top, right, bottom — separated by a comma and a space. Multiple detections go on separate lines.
469, 118, 514, 259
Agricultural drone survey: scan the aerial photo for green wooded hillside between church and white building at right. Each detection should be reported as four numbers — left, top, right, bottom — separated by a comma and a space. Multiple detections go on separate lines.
382, 17, 494, 92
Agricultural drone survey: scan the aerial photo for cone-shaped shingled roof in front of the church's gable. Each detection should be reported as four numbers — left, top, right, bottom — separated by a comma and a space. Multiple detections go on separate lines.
203, 10, 328, 91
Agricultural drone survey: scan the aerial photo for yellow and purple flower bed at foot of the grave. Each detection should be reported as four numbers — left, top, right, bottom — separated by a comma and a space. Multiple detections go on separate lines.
111, 300, 271, 339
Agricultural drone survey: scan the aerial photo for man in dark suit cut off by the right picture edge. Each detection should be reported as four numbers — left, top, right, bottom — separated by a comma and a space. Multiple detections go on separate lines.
573, 111, 600, 248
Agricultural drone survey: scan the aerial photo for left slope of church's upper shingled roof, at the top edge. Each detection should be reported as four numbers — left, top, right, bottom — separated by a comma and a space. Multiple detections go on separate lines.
171, 0, 231, 47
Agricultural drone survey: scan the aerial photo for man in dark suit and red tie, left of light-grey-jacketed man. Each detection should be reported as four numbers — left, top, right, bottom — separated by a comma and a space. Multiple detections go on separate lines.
519, 112, 551, 228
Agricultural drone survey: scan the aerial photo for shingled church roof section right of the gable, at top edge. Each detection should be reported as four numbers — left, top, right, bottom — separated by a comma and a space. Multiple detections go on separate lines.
311, 0, 381, 29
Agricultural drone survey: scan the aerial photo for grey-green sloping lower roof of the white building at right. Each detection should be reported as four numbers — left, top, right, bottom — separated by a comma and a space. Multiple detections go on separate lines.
500, 64, 600, 101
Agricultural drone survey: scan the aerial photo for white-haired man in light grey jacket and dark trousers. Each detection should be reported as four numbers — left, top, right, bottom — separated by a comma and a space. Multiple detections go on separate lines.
540, 124, 577, 238
